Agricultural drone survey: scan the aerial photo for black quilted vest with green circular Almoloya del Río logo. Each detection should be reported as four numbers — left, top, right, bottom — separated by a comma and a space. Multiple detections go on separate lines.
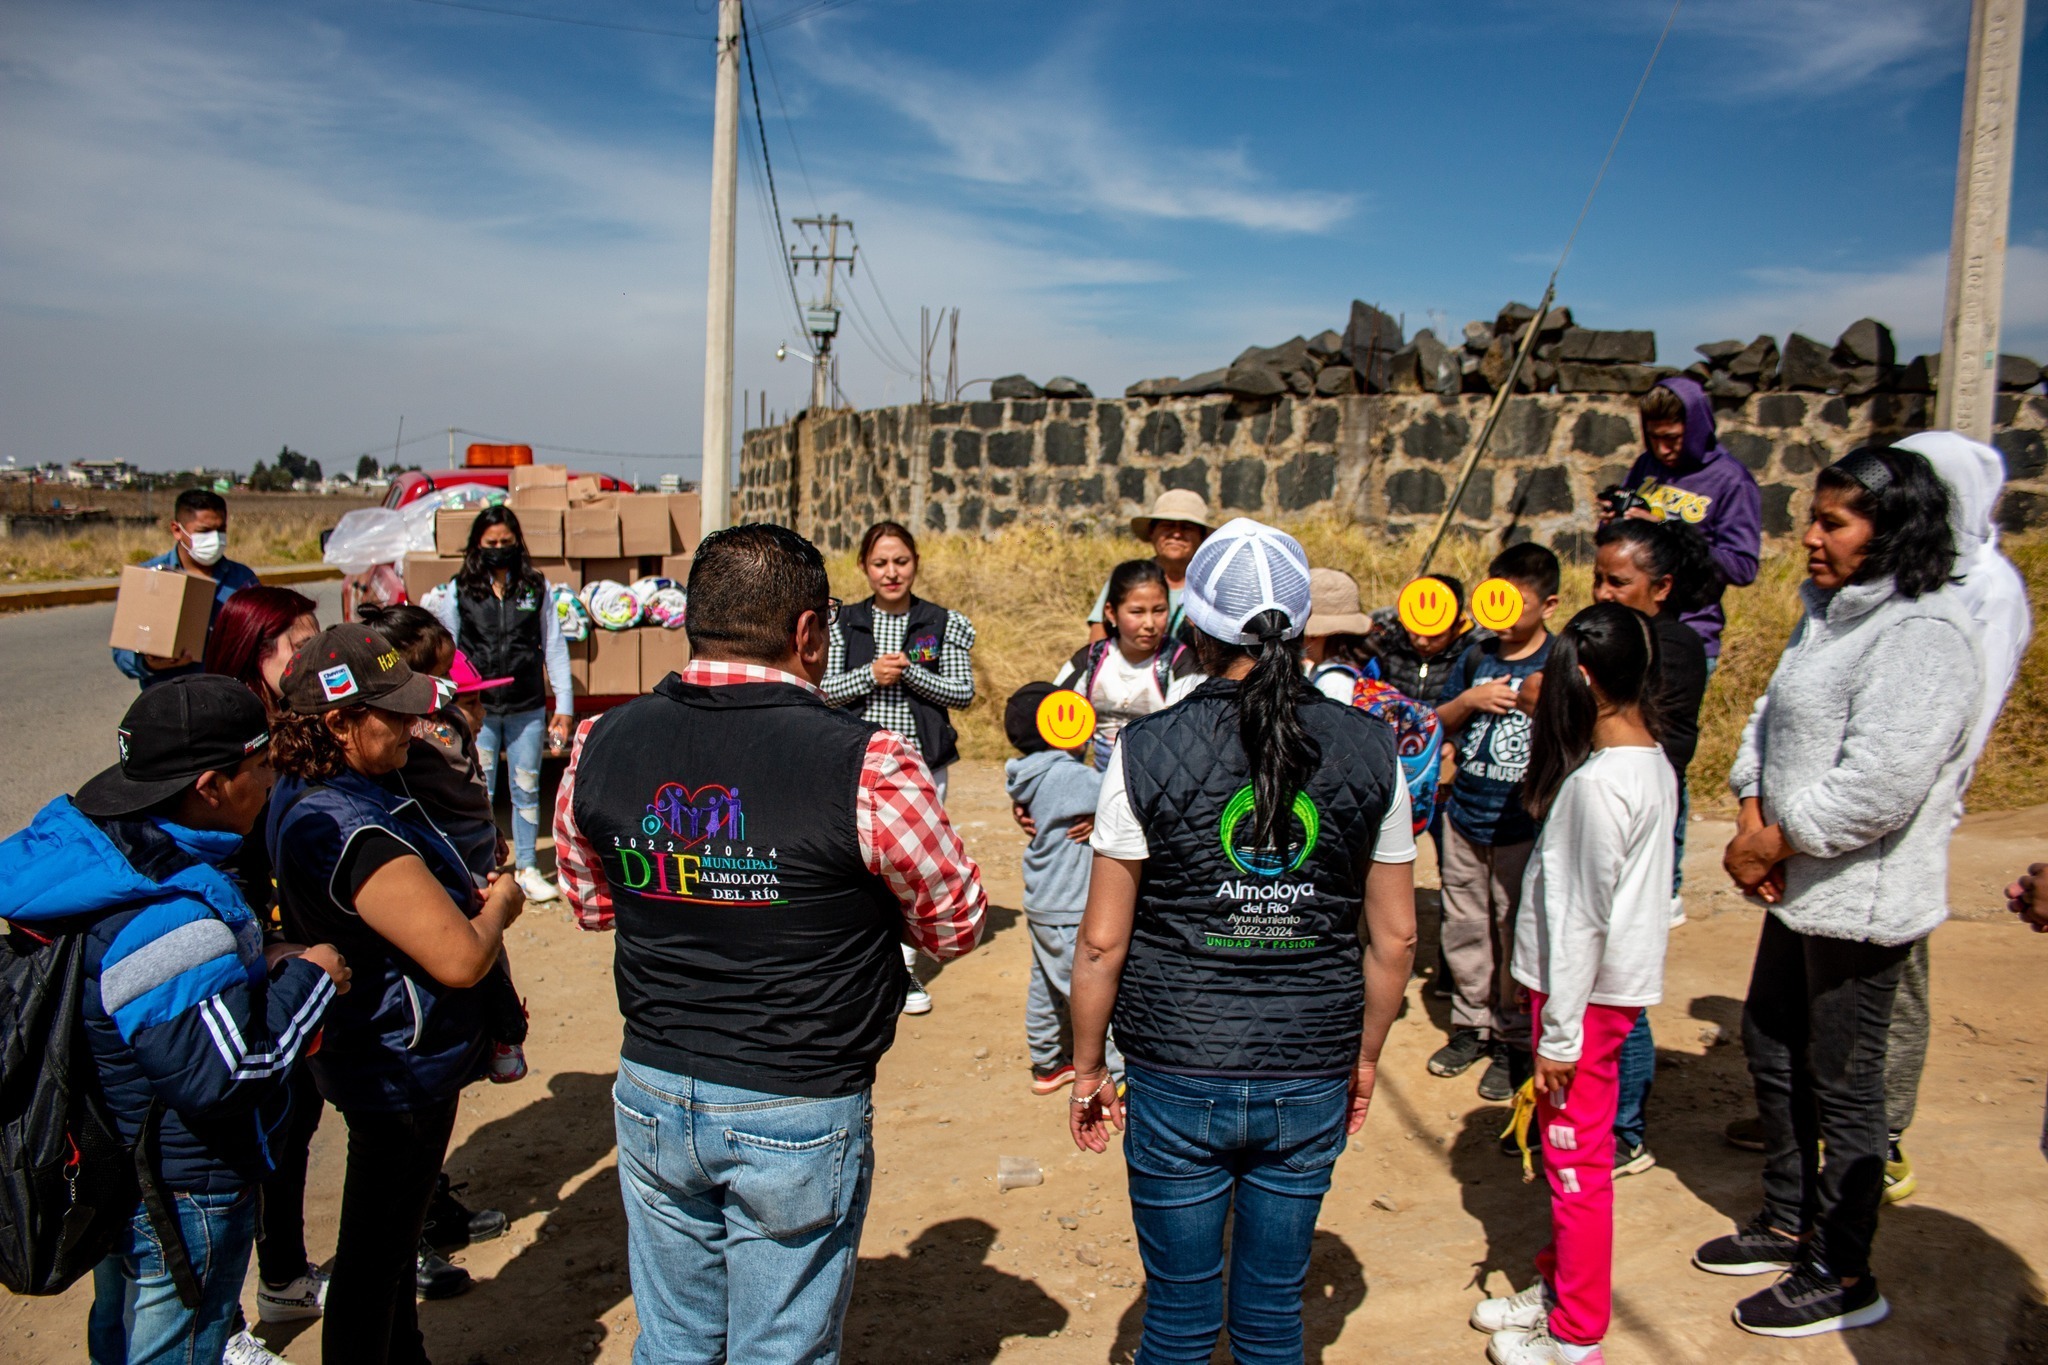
1114, 679, 1395, 1076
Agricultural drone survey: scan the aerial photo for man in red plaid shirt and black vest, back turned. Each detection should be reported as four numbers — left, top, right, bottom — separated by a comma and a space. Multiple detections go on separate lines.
555, 526, 987, 1363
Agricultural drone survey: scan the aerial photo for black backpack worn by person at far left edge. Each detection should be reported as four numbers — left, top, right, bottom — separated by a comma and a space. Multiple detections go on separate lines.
0, 917, 199, 1308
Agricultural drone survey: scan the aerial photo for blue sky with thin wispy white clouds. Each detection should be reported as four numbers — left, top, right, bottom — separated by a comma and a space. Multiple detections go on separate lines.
0, 0, 2048, 477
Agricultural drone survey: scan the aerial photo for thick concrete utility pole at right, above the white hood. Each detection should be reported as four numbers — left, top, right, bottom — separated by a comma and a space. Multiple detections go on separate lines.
1935, 0, 2028, 442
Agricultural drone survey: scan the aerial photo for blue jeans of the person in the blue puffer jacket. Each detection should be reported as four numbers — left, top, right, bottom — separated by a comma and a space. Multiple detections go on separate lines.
86, 1187, 256, 1365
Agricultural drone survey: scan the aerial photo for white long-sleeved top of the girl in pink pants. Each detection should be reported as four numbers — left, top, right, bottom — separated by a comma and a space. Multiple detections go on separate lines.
1507, 745, 1677, 1062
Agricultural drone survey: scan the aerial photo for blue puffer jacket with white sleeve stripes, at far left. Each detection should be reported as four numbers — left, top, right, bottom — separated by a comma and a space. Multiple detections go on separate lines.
0, 796, 334, 1193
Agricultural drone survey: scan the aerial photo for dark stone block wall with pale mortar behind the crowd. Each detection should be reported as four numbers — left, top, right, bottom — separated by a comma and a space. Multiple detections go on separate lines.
735, 391, 2048, 553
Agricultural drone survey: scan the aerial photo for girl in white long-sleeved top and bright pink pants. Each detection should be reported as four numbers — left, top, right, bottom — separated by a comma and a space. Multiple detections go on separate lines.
1473, 602, 1677, 1365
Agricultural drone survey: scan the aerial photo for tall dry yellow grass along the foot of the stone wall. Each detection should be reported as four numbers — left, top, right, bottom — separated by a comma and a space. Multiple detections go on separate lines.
847, 520, 2048, 812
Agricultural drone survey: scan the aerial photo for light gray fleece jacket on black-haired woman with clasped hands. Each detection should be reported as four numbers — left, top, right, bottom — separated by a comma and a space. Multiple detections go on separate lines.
1729, 579, 1982, 945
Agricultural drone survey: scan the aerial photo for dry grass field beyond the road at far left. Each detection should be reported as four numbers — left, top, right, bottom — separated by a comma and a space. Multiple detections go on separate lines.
0, 493, 369, 583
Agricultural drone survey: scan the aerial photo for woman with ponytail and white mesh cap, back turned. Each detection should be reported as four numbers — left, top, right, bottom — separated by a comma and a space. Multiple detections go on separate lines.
1069, 518, 1415, 1361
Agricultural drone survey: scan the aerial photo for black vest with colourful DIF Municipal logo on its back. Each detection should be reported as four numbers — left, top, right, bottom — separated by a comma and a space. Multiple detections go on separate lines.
571, 673, 905, 1097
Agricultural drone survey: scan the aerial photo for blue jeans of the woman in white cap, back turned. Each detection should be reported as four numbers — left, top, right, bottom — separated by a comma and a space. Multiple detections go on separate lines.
1124, 1060, 1350, 1365
